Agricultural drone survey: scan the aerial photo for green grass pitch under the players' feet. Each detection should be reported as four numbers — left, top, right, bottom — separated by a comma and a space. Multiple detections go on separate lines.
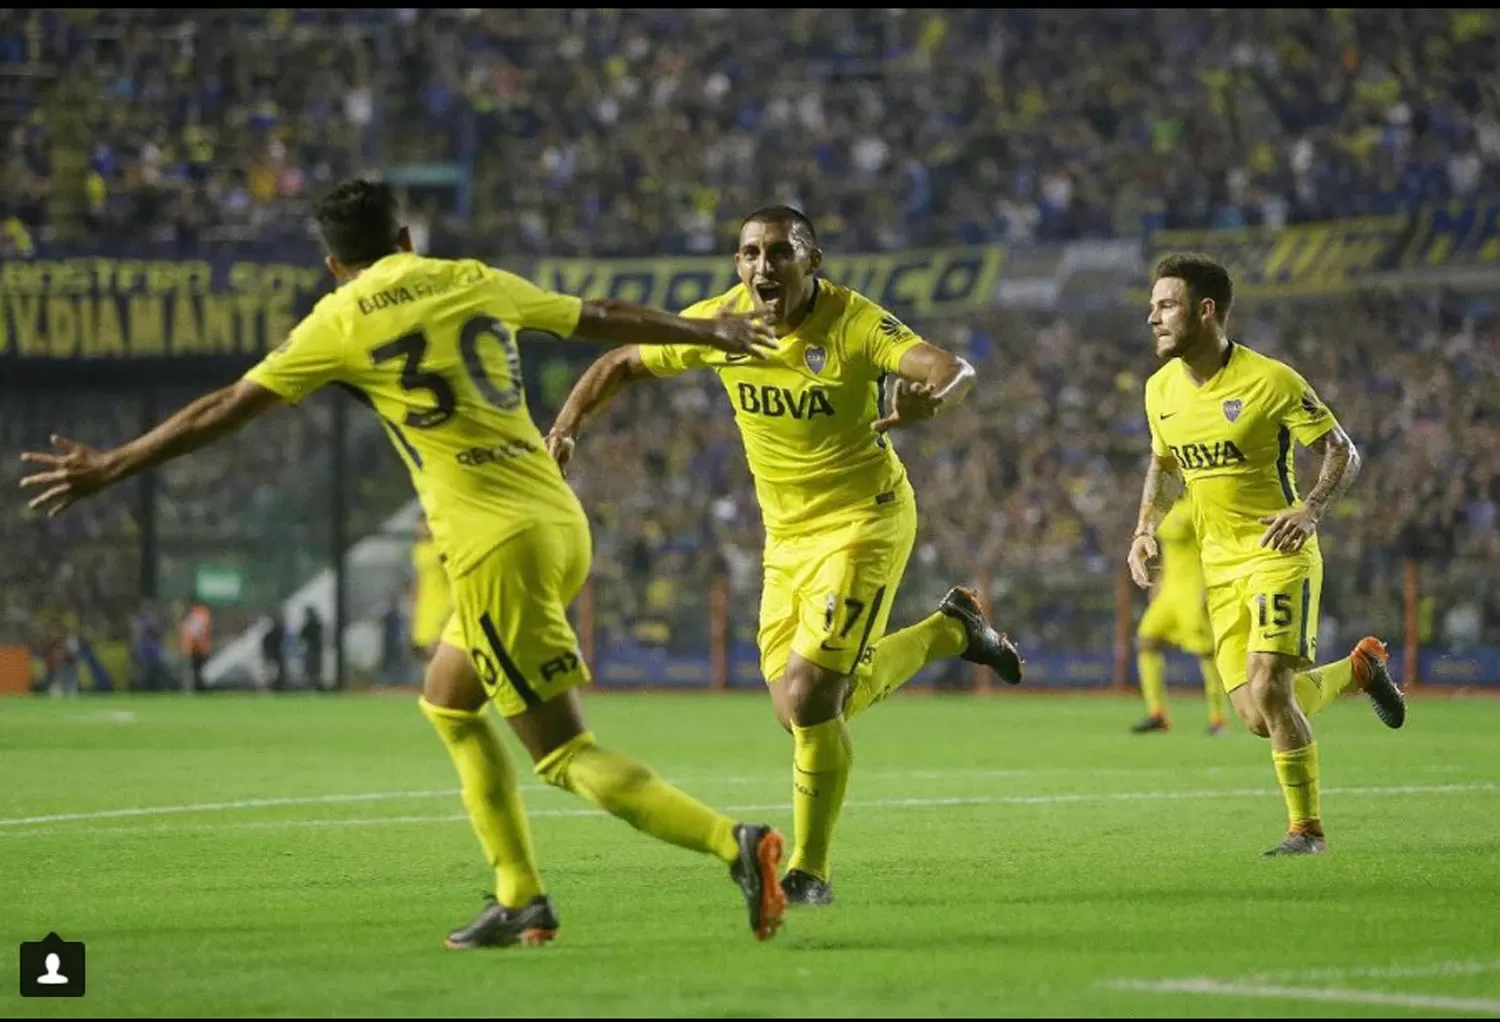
0, 693, 1500, 1017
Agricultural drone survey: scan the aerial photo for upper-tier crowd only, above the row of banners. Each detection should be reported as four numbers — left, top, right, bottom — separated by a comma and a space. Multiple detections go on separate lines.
0, 8, 1500, 255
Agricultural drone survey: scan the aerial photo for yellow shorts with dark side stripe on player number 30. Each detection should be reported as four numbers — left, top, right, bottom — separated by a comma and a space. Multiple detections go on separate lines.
443, 518, 594, 717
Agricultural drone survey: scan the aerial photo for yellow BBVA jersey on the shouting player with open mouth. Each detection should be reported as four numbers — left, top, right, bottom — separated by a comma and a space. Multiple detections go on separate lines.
641, 281, 921, 534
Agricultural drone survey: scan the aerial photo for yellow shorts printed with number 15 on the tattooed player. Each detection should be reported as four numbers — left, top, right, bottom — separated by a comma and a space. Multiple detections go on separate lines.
1208, 557, 1323, 692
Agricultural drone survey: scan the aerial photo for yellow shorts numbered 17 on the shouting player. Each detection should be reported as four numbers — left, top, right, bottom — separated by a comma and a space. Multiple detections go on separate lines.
756, 494, 917, 681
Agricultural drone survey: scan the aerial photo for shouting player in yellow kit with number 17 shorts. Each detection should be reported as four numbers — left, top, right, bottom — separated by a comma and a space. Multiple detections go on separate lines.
548, 207, 1022, 905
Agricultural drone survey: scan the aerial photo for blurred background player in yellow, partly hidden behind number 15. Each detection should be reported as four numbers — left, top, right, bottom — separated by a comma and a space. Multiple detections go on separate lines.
1131, 498, 1224, 734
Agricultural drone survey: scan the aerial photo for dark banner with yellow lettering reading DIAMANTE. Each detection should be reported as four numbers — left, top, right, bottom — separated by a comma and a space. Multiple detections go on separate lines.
0, 257, 332, 362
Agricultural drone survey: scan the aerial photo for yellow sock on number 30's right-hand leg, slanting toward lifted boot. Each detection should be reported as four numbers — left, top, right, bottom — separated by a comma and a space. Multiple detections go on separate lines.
536, 731, 740, 863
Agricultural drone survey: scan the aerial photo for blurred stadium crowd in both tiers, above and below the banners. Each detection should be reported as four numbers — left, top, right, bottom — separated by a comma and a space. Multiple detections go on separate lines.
0, 9, 1500, 684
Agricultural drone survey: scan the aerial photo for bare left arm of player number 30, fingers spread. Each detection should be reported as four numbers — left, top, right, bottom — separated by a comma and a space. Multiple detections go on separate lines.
21, 380, 281, 515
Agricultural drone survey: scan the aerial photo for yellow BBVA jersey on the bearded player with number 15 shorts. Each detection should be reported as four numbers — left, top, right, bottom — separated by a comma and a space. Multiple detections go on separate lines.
1146, 344, 1338, 585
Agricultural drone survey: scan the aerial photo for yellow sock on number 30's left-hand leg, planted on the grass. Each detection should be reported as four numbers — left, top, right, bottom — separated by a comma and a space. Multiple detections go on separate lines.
417, 698, 542, 908
